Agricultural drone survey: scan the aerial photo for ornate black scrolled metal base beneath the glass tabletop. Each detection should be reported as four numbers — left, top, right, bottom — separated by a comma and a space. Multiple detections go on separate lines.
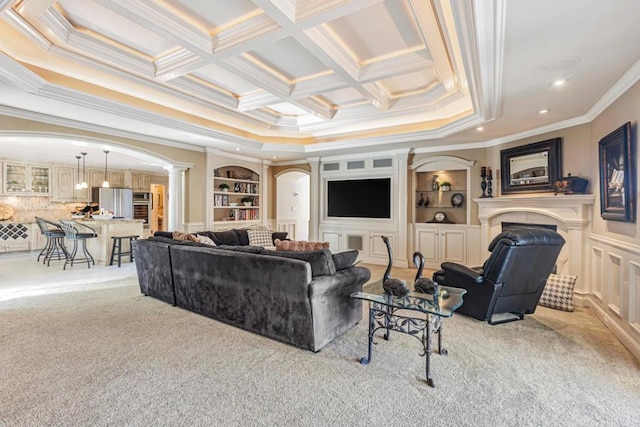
360, 302, 447, 387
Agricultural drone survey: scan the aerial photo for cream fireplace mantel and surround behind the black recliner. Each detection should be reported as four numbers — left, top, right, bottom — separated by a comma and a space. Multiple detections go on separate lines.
473, 194, 595, 300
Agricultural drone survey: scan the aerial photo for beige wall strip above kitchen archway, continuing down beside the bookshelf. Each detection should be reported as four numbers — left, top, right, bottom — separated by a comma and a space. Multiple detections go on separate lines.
0, 115, 206, 223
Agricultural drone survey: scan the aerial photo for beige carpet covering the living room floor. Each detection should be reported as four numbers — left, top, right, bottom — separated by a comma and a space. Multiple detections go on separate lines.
0, 267, 640, 426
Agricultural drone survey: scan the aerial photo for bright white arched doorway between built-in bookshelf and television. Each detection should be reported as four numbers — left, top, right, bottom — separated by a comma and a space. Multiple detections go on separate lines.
276, 170, 311, 240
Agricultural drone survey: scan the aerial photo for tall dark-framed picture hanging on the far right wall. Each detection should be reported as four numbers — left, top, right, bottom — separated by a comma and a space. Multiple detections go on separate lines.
598, 122, 637, 222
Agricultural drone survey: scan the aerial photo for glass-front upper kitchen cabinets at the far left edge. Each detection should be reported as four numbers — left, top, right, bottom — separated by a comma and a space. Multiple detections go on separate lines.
2, 163, 51, 196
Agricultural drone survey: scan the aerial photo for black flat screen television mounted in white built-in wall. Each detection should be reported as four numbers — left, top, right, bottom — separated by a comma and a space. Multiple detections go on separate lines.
327, 178, 391, 219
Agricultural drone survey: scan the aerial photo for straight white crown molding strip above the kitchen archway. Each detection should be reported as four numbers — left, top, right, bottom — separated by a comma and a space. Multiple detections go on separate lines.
0, 105, 203, 152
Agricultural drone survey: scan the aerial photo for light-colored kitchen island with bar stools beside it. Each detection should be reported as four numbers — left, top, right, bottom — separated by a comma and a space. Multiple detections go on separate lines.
74, 219, 144, 265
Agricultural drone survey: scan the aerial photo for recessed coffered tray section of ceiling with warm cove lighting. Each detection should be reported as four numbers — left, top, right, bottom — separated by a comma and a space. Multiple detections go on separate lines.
0, 0, 478, 145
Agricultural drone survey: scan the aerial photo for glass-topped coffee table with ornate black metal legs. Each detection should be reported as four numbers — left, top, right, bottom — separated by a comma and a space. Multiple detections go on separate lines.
351, 286, 467, 387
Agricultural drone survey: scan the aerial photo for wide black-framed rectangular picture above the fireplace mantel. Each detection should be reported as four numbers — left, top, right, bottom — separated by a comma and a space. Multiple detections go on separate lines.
500, 138, 562, 194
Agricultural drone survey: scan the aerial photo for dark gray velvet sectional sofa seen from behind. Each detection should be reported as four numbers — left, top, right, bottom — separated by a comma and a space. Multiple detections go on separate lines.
133, 232, 371, 352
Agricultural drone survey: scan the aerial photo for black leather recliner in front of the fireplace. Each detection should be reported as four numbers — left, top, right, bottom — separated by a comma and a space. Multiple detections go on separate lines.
433, 228, 565, 325
